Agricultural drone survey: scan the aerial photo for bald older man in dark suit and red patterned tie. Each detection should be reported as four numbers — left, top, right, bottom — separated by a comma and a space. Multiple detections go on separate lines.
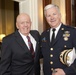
0, 13, 40, 75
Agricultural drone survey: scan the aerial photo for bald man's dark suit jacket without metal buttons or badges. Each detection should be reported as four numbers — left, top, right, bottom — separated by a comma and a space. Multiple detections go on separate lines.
0, 31, 40, 75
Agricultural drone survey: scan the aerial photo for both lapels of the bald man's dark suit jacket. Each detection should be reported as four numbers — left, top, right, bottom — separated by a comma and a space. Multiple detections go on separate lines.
15, 31, 39, 58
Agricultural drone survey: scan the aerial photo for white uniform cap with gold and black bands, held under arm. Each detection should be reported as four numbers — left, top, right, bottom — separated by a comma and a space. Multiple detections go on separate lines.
60, 48, 76, 66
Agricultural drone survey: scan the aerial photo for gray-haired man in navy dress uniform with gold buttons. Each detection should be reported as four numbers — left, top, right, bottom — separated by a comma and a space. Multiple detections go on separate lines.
41, 4, 76, 75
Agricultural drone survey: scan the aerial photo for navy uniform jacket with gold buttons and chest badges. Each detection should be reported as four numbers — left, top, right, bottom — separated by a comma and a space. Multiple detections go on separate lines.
41, 24, 76, 75
